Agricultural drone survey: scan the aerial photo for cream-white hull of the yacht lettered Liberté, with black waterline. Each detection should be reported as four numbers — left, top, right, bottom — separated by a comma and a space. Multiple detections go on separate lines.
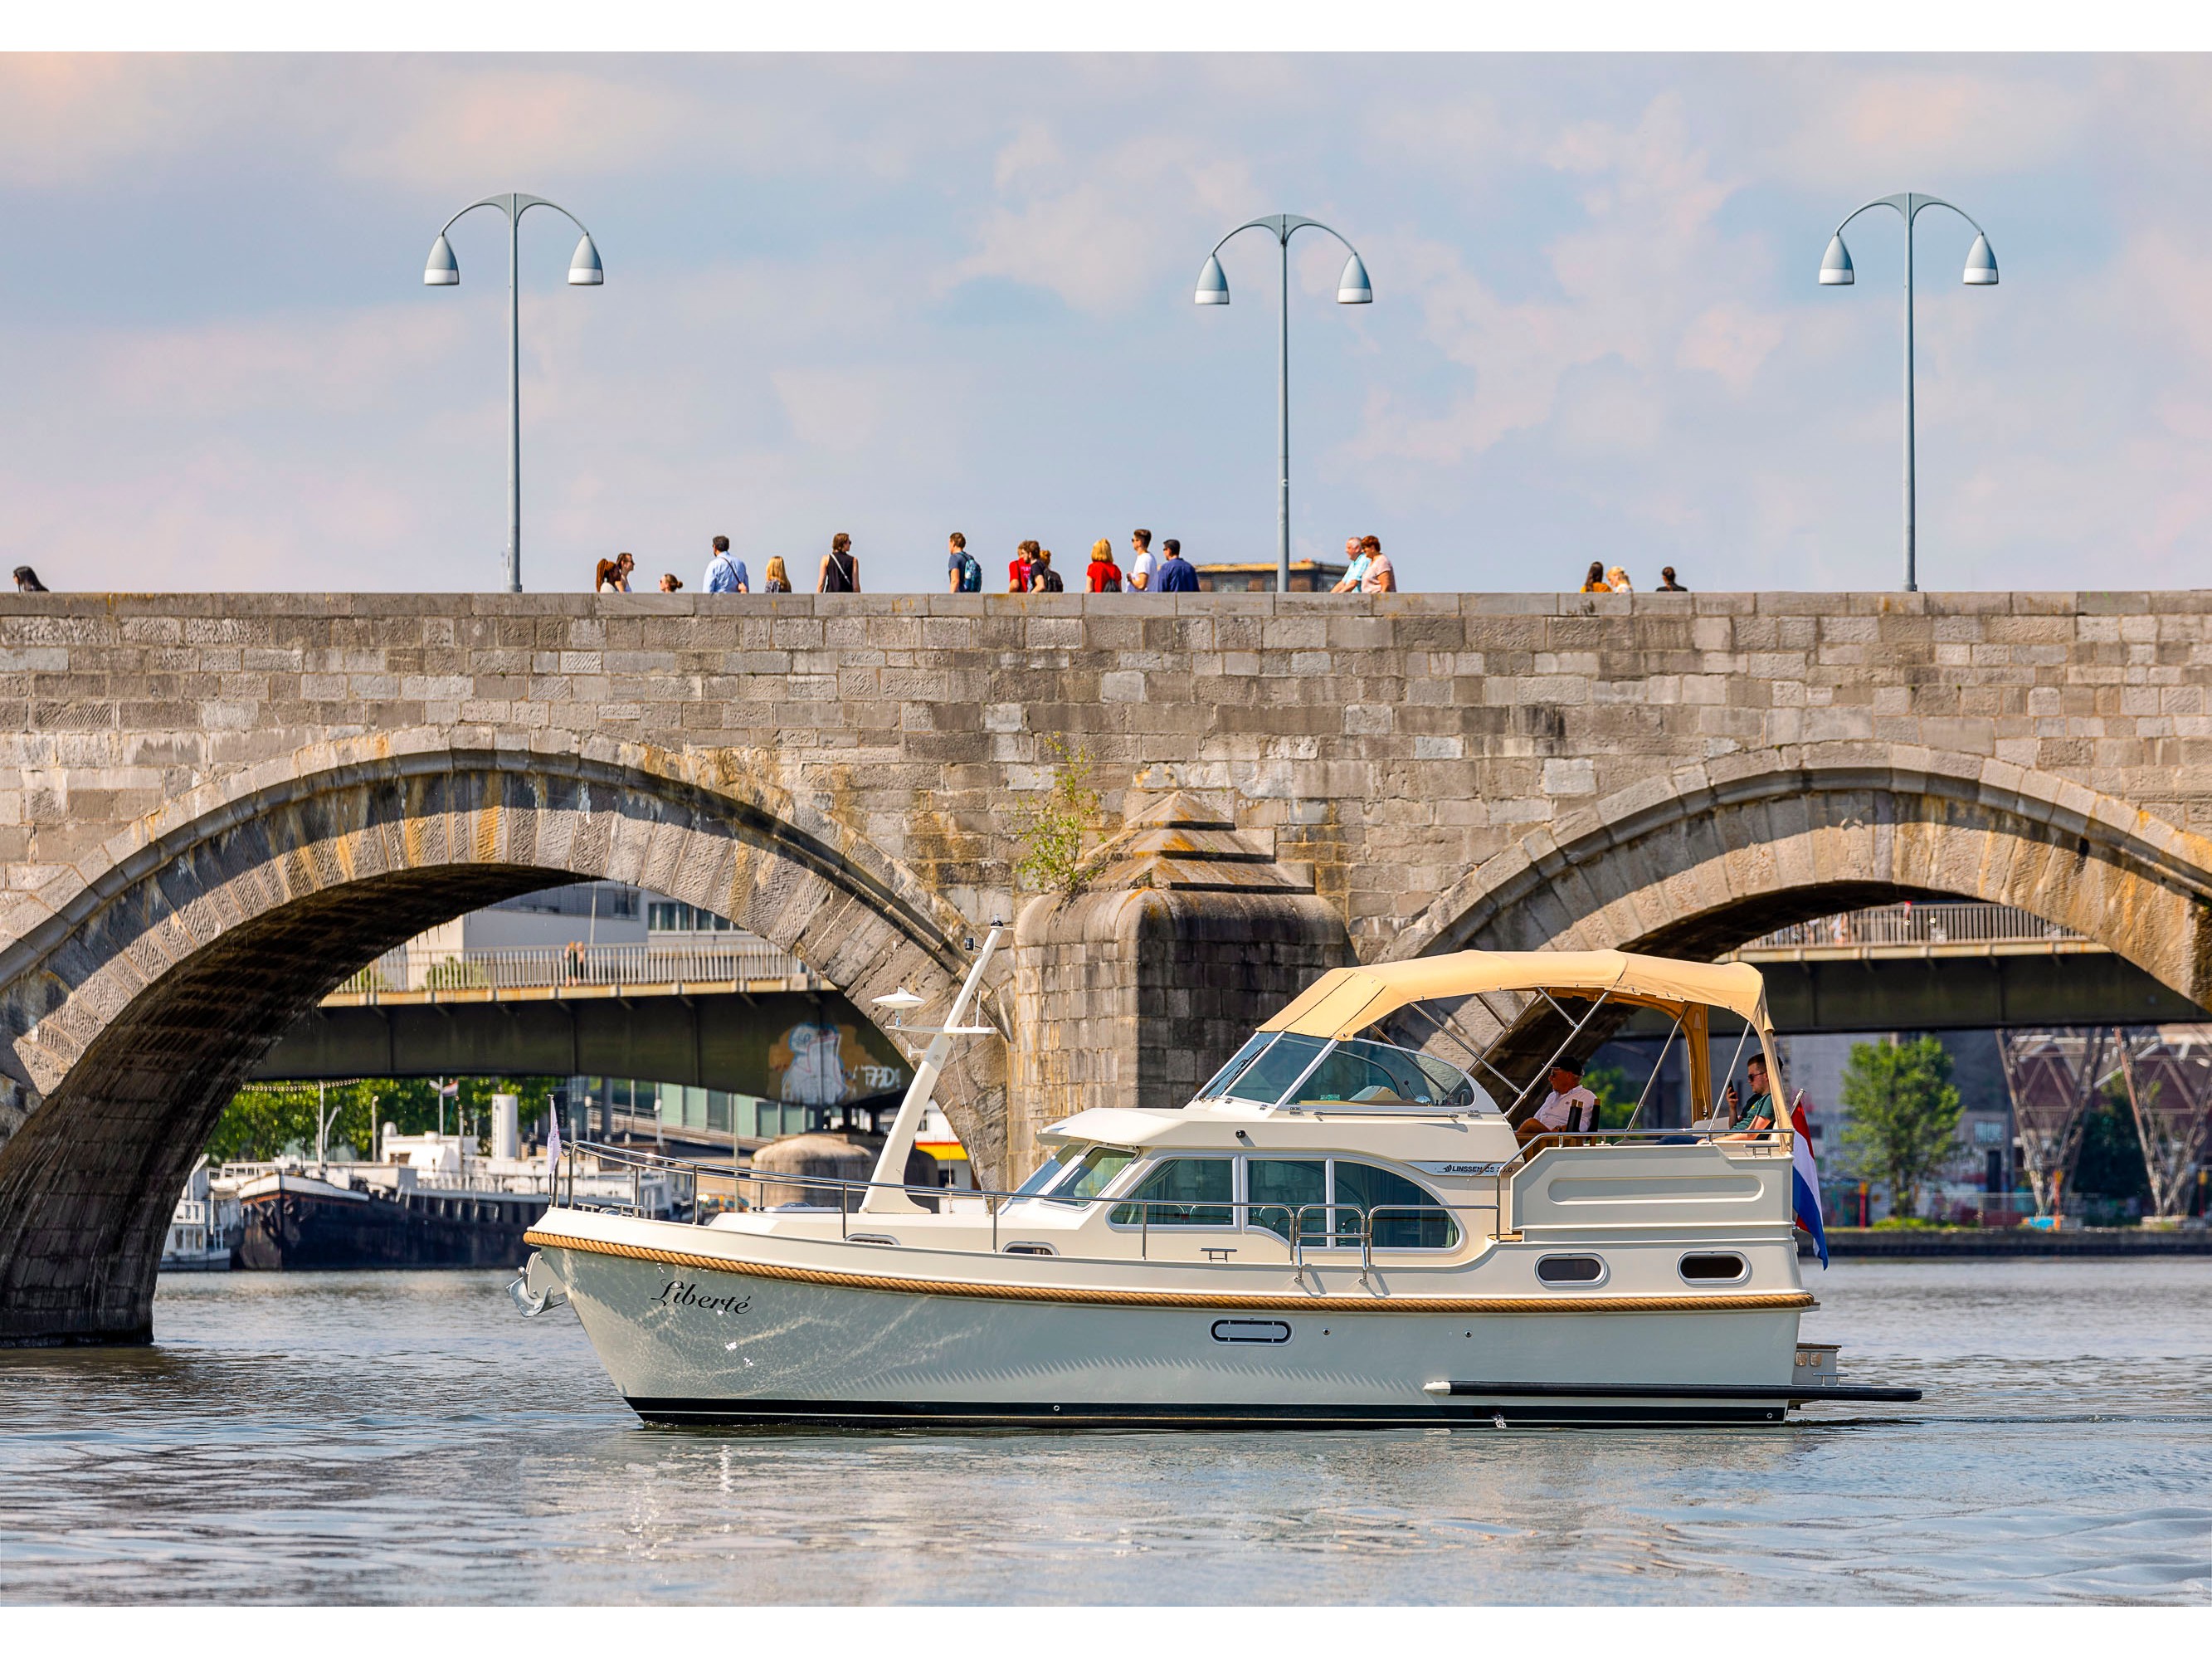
534, 1230, 1811, 1429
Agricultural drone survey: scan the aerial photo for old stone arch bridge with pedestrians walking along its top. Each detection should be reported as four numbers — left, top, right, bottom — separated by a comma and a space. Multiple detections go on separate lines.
0, 593, 2212, 1340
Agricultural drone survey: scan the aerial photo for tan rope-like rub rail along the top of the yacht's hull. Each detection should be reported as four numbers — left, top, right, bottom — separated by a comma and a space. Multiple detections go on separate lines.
522, 1227, 1818, 1314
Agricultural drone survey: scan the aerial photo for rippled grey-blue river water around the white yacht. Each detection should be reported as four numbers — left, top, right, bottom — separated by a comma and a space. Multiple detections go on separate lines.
0, 1259, 2212, 1603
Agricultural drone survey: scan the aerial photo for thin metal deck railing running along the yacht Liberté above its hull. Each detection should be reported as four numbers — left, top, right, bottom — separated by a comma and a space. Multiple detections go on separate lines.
555, 1128, 1790, 1283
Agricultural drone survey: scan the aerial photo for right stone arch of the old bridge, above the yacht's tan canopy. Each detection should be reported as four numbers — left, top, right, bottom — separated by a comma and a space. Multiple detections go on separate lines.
1382, 745, 2212, 1004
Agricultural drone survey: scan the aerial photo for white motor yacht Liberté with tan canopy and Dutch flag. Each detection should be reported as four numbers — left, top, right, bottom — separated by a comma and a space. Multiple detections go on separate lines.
514, 934, 1920, 1427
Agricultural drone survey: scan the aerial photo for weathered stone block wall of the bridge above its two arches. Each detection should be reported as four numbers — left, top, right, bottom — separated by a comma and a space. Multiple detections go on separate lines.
12, 593, 2212, 973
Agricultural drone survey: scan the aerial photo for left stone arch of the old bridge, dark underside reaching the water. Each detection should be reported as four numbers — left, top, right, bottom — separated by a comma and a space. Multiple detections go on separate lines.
0, 730, 1006, 1343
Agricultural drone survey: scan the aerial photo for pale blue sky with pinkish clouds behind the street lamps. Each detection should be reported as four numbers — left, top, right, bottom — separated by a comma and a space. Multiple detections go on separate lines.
0, 53, 2212, 593
